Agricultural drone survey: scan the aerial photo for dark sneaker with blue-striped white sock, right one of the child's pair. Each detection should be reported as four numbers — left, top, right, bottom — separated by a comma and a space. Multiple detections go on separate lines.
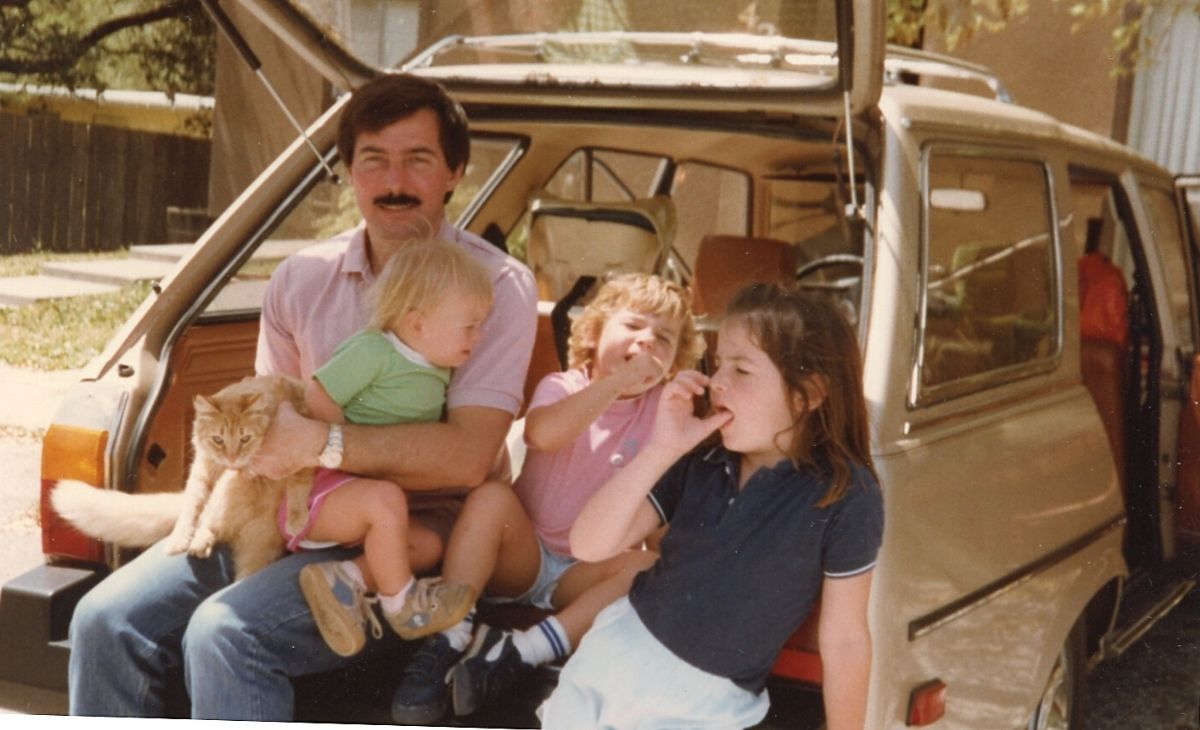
450, 624, 534, 714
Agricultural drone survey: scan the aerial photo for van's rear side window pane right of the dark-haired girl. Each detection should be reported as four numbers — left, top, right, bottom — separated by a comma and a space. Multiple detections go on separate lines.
916, 148, 1060, 402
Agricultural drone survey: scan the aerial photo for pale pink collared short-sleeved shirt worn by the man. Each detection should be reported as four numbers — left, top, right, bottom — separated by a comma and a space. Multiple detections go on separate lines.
254, 222, 538, 415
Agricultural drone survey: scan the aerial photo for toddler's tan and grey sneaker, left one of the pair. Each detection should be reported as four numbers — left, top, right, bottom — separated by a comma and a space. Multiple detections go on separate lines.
300, 561, 383, 657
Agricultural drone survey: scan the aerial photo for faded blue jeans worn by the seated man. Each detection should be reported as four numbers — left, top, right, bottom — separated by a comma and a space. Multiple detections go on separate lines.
67, 543, 398, 720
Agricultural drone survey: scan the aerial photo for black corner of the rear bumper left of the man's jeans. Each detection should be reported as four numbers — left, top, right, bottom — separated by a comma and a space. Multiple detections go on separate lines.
0, 566, 103, 690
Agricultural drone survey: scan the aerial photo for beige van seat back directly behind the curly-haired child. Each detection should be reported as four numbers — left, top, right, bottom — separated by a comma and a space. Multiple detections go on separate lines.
527, 192, 676, 301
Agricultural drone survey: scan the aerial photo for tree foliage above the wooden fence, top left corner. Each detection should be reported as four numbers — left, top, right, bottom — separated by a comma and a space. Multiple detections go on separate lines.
0, 0, 216, 95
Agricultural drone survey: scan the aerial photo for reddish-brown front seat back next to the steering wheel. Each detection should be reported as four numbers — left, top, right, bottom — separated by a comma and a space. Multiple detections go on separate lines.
691, 234, 800, 318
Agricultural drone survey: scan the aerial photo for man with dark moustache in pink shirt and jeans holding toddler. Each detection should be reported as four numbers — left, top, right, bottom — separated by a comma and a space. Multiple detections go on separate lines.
68, 76, 536, 720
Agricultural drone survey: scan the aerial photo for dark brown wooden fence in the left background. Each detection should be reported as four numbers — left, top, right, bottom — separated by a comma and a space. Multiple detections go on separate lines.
0, 114, 211, 255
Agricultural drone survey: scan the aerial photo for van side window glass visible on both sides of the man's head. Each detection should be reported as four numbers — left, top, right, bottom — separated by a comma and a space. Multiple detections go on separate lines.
204, 137, 518, 315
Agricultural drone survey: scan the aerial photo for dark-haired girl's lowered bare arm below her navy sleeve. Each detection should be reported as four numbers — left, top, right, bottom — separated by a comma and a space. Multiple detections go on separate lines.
817, 570, 874, 730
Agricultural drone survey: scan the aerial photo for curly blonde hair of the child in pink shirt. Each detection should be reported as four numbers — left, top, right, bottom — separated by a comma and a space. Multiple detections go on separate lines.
566, 274, 704, 377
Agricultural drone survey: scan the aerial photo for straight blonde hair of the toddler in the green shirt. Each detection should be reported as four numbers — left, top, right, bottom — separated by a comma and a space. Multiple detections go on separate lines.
367, 238, 492, 330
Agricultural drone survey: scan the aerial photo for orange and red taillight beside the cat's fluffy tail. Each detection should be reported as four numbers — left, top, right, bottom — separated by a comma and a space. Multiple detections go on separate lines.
41, 424, 108, 563
